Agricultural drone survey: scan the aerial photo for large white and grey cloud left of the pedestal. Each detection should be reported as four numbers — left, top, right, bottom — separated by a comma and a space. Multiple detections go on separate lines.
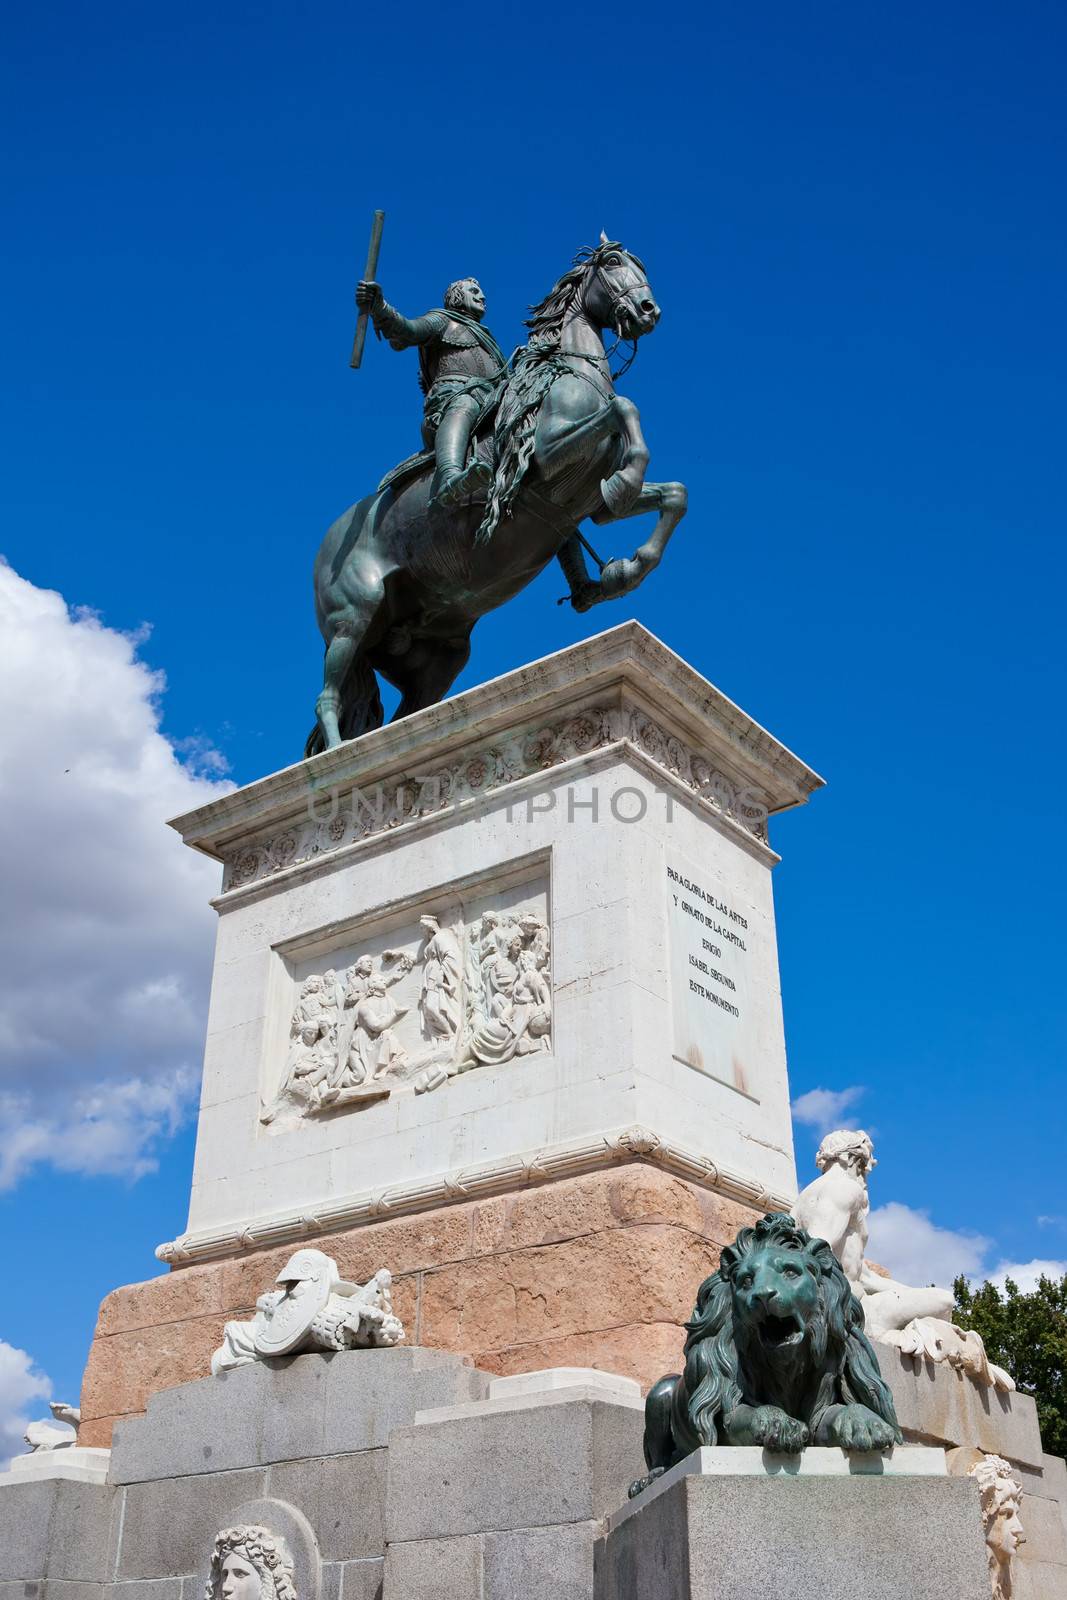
0, 562, 232, 1189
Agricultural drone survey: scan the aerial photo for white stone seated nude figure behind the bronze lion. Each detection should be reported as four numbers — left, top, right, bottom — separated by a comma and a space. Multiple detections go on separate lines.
793, 1128, 1016, 1390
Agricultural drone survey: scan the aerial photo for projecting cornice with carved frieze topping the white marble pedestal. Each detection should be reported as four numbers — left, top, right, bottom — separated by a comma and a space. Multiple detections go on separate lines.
171, 622, 822, 901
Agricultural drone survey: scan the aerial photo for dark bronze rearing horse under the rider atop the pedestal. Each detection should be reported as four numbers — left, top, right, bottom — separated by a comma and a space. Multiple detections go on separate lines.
306, 238, 686, 755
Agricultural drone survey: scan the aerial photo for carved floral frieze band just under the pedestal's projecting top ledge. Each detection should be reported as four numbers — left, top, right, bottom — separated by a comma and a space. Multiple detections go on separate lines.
222, 706, 768, 891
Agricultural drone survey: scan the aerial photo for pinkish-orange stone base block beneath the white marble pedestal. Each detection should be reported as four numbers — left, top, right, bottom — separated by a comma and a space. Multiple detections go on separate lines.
78, 1162, 757, 1445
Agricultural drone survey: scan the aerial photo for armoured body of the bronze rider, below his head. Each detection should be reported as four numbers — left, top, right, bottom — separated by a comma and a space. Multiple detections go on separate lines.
373, 301, 506, 506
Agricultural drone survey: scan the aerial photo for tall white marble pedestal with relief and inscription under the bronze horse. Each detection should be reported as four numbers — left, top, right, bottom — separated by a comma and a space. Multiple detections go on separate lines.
158, 622, 821, 1262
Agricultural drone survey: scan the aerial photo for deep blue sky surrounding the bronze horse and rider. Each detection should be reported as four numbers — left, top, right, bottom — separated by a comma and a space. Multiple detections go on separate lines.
0, 0, 1067, 1453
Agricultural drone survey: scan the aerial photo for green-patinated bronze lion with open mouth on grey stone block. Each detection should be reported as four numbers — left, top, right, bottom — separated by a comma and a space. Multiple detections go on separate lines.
630, 1211, 902, 1496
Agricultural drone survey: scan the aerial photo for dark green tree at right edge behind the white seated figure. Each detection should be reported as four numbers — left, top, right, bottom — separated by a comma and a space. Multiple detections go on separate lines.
952, 1274, 1067, 1456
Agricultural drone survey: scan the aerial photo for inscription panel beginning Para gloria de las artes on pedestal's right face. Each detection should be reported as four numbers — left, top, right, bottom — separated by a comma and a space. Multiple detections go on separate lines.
665, 851, 752, 1094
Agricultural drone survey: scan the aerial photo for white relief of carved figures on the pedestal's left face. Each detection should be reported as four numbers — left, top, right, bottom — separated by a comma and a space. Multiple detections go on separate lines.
261, 907, 552, 1128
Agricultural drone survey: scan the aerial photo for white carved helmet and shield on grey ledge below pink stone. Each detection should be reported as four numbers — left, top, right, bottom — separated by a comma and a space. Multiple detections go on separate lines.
211, 1250, 405, 1378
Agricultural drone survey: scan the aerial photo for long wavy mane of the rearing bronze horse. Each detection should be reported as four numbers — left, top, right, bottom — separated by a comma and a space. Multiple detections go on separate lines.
475, 238, 645, 544
